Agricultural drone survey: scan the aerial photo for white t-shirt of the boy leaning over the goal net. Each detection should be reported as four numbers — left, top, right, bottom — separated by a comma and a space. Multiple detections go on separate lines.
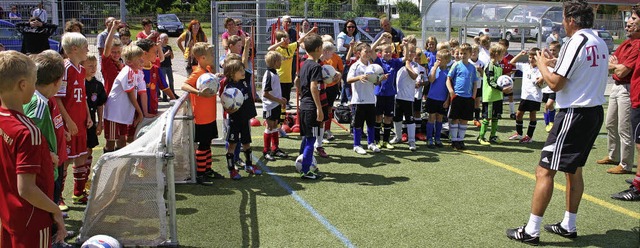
104, 66, 147, 125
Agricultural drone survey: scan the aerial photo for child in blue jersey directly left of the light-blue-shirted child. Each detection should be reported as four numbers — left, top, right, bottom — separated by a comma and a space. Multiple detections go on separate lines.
426, 49, 451, 148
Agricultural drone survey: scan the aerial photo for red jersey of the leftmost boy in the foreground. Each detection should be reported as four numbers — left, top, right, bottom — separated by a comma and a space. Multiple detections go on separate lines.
0, 107, 54, 232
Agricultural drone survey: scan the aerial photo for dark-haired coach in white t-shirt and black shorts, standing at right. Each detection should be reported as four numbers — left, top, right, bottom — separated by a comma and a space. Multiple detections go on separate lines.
507, 0, 609, 244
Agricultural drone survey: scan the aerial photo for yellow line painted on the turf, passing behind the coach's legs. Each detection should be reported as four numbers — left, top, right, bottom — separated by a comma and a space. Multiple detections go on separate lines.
464, 151, 640, 219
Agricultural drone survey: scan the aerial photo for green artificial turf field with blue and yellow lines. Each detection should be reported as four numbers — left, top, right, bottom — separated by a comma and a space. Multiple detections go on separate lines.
65, 106, 640, 247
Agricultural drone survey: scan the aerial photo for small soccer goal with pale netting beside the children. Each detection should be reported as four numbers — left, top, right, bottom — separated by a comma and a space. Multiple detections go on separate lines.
78, 94, 195, 247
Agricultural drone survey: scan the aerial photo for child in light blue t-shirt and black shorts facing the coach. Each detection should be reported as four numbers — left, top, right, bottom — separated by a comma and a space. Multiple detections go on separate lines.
447, 43, 479, 150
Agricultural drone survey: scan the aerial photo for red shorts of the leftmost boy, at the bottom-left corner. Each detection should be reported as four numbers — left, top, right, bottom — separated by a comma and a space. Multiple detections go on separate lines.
0, 227, 52, 248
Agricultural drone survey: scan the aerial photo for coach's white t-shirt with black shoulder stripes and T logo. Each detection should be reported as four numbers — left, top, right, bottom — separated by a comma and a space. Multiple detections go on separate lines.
553, 29, 609, 108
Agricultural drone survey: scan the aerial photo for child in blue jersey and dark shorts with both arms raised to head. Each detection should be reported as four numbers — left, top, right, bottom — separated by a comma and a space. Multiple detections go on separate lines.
373, 34, 406, 149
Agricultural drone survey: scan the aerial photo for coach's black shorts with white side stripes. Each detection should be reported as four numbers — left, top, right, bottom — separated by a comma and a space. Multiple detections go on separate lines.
539, 106, 604, 174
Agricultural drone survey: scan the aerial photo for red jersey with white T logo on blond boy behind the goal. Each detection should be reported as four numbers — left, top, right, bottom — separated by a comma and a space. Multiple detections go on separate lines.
56, 59, 88, 128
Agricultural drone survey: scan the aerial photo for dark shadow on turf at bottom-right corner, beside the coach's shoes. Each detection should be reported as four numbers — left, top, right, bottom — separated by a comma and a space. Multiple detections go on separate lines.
541, 226, 640, 248
